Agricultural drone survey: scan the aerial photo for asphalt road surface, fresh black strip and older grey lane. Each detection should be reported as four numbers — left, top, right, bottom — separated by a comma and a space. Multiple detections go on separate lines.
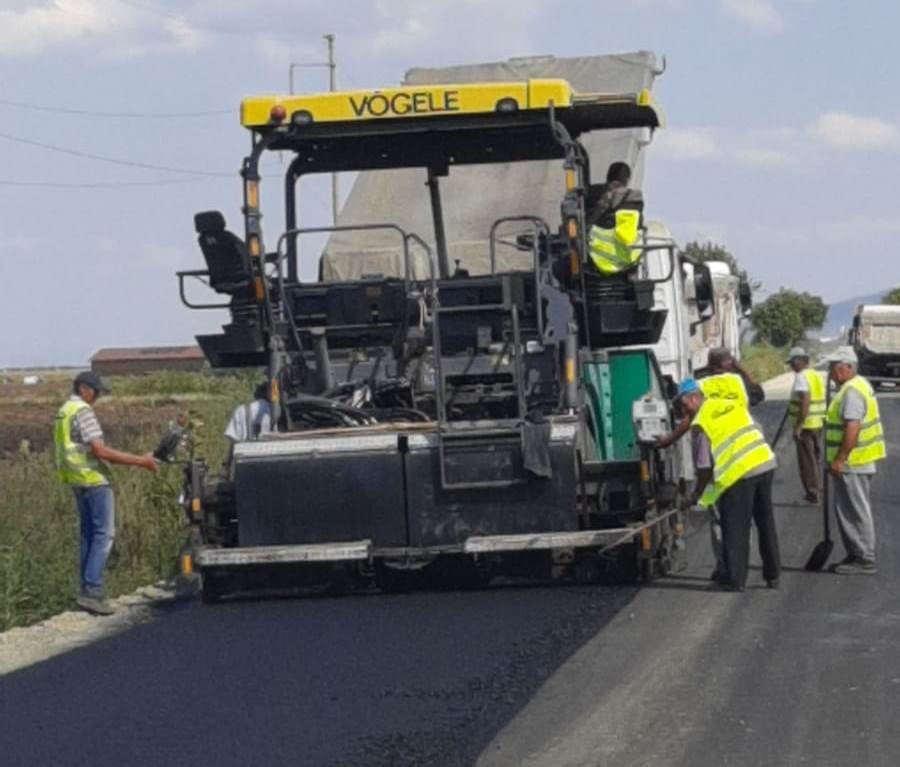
0, 397, 900, 767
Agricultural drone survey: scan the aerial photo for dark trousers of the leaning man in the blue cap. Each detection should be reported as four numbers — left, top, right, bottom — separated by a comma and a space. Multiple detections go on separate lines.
717, 471, 781, 588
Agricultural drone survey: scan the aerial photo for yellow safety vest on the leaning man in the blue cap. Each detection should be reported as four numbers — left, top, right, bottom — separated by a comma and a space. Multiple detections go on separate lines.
693, 399, 775, 506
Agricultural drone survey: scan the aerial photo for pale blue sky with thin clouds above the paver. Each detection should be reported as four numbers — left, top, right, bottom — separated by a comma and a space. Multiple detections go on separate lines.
0, 0, 900, 366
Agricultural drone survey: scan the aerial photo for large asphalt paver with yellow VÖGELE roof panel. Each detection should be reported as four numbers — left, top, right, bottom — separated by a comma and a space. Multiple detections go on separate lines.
178, 80, 682, 599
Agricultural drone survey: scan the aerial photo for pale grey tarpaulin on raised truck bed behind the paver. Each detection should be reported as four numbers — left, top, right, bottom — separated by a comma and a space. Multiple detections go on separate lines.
322, 51, 658, 280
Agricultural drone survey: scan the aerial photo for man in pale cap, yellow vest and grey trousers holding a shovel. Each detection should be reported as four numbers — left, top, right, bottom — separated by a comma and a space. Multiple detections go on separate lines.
825, 346, 886, 575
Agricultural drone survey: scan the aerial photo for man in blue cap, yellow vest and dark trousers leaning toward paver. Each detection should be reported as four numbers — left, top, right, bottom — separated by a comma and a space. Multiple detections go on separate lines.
679, 378, 781, 591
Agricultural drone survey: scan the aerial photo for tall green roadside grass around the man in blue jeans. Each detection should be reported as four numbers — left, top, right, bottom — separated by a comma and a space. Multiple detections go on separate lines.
0, 373, 255, 630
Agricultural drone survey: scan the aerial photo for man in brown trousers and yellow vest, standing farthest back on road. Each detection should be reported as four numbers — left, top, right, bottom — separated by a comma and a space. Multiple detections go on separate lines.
787, 346, 825, 503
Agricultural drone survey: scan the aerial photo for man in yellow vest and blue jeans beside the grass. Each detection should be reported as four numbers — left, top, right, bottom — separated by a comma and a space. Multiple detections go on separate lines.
53, 372, 159, 615
